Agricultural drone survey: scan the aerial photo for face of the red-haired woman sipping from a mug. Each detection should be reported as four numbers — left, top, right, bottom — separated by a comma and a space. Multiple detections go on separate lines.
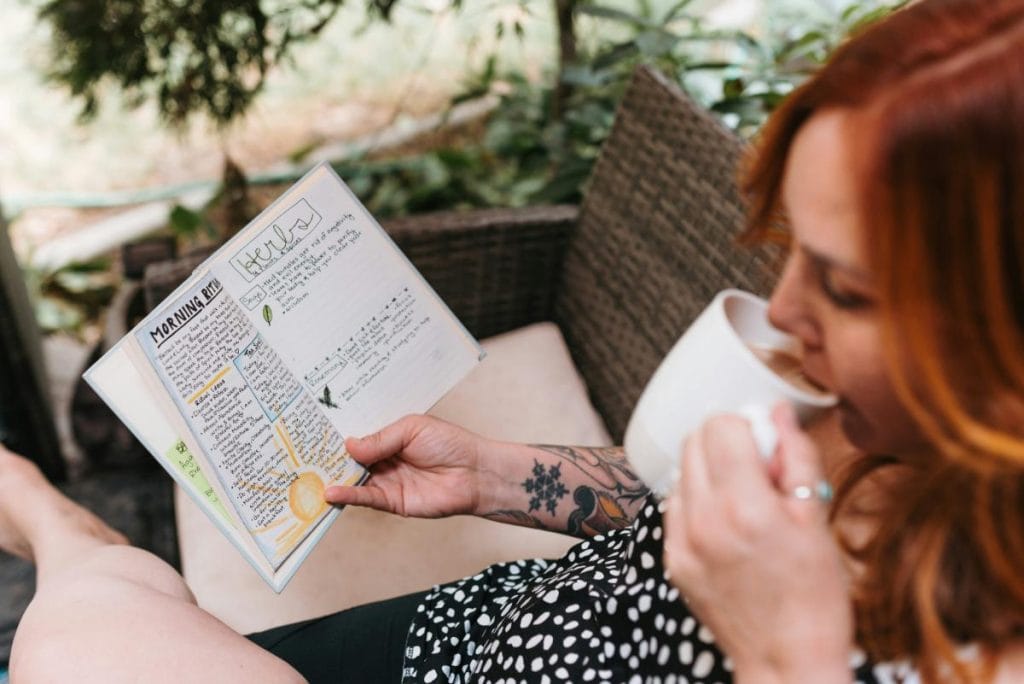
769, 110, 923, 453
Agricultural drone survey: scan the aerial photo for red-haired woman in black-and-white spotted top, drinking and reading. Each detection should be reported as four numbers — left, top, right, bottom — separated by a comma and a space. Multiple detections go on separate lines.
6, 0, 1024, 682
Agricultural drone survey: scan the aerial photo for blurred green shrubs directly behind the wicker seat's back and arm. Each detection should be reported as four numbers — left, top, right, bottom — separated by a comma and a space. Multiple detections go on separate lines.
336, 0, 902, 216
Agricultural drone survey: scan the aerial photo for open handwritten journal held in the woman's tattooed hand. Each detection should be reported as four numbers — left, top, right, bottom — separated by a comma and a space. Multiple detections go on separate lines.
85, 164, 482, 592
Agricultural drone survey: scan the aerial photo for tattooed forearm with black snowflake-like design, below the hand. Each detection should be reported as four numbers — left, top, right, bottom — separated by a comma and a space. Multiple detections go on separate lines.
484, 445, 647, 538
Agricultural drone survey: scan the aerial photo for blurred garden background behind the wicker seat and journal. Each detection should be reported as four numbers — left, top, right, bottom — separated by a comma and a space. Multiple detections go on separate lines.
0, 0, 901, 672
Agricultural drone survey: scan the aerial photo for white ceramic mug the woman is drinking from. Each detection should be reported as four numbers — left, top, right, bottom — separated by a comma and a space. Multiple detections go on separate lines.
625, 290, 837, 498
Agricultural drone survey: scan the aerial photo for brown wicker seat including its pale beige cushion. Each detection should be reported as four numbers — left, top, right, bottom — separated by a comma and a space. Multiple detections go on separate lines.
138, 63, 790, 632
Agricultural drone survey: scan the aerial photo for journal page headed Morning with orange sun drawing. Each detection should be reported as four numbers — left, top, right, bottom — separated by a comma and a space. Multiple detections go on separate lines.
135, 273, 366, 569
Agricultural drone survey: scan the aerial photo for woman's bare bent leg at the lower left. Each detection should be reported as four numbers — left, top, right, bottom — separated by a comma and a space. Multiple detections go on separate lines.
0, 447, 302, 682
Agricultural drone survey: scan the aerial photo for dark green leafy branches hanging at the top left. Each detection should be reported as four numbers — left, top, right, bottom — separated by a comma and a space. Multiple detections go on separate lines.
39, 0, 394, 124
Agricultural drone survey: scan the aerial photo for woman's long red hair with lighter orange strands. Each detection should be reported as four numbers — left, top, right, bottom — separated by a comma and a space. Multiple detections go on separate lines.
742, 0, 1024, 680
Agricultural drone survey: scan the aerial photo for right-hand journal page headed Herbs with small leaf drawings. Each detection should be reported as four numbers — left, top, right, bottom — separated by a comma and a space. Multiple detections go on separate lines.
211, 165, 481, 444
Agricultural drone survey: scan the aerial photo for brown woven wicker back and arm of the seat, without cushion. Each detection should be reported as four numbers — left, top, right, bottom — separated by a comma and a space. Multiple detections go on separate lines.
145, 67, 772, 441
